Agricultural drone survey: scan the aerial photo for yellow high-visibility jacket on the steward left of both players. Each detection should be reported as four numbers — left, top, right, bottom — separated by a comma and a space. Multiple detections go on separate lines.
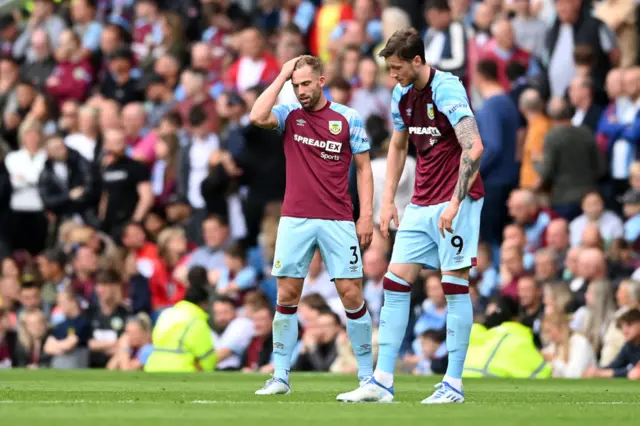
144, 301, 217, 372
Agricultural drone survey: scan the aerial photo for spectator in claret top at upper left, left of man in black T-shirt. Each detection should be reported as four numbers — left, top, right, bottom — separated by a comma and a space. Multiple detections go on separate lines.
45, 30, 93, 106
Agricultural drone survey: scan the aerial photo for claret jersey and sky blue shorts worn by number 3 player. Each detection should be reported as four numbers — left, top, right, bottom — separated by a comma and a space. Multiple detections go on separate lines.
272, 102, 370, 279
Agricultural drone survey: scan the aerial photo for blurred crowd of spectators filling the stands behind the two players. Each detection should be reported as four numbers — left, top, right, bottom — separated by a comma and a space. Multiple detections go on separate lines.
0, 0, 640, 379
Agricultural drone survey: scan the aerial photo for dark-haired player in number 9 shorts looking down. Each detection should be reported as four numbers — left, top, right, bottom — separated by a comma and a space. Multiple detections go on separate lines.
338, 29, 484, 404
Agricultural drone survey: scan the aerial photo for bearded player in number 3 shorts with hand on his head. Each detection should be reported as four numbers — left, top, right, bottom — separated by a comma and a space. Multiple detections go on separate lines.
250, 55, 373, 395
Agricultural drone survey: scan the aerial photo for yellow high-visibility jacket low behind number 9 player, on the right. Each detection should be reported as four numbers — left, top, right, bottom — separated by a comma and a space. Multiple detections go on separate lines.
462, 322, 551, 378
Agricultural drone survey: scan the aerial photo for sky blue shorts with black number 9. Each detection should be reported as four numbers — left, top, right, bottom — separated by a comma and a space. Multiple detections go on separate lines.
391, 197, 484, 271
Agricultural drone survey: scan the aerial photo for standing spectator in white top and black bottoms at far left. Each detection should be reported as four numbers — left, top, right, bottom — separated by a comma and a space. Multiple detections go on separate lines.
5, 121, 48, 255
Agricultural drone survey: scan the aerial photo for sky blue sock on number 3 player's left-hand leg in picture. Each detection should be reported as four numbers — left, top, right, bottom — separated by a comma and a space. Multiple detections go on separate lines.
273, 305, 298, 383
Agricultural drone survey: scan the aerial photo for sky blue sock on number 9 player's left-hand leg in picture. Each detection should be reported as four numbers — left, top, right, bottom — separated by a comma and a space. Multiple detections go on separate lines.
374, 272, 411, 387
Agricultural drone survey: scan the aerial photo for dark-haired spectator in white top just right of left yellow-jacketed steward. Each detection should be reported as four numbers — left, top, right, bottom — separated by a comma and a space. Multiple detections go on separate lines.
213, 296, 255, 371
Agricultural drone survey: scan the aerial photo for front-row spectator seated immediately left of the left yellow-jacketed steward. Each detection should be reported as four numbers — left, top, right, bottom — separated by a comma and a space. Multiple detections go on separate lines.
107, 313, 153, 371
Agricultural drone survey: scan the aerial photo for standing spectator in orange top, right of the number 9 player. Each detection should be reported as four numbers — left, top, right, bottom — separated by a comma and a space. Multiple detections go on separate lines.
516, 87, 552, 190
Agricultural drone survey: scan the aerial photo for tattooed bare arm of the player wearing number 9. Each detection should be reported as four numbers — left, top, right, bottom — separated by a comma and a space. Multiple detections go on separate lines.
453, 117, 481, 201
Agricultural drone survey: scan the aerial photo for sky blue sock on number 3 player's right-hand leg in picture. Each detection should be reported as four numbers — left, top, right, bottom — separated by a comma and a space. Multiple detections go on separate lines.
345, 302, 373, 380
